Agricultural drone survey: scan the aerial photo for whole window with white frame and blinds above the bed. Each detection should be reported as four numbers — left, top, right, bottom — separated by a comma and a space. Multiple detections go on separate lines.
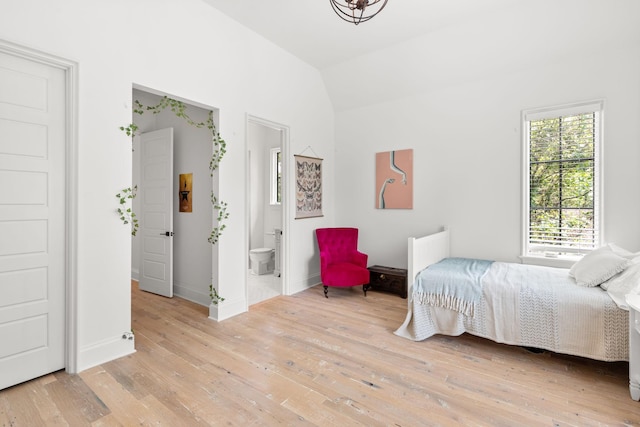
523, 102, 602, 258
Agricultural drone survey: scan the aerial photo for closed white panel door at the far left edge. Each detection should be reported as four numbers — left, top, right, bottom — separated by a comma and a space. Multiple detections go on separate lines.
0, 52, 66, 389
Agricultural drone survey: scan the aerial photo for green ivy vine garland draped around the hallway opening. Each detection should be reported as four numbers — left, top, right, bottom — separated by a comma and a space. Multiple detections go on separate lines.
116, 96, 229, 304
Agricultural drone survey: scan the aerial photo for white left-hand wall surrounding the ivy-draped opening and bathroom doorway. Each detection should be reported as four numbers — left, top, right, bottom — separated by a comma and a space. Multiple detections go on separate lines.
0, 0, 333, 370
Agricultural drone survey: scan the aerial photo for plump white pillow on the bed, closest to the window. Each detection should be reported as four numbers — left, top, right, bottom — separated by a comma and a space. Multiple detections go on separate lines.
569, 245, 631, 287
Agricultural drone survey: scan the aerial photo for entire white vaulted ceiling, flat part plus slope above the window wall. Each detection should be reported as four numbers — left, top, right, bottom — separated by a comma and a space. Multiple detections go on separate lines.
202, 0, 640, 111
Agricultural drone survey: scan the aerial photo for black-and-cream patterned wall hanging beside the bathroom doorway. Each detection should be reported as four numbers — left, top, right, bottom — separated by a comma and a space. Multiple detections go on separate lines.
293, 155, 322, 219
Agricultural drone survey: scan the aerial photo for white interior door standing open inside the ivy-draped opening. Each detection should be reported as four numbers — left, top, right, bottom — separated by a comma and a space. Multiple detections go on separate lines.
138, 128, 173, 297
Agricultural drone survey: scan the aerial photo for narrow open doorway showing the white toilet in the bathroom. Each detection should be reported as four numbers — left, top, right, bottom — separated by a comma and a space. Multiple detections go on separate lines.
246, 116, 288, 306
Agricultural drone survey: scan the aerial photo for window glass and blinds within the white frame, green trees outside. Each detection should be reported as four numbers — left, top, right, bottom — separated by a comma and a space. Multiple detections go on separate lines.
528, 105, 597, 253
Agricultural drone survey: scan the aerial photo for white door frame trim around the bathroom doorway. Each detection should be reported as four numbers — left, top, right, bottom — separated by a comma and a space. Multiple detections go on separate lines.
244, 114, 292, 300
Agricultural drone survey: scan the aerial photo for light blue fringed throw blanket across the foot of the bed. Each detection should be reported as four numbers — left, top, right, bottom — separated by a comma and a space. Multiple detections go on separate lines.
413, 258, 493, 317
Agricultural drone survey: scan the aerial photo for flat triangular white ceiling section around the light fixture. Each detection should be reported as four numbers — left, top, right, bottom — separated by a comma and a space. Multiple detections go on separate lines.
203, 0, 516, 70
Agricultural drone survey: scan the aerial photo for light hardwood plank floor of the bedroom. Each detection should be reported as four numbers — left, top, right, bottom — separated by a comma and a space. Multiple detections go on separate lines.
0, 282, 640, 427
